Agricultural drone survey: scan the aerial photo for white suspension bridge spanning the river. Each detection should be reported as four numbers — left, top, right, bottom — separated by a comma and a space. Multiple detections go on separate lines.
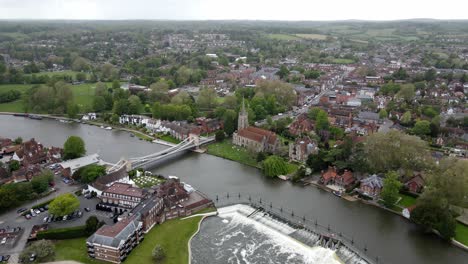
107, 134, 215, 173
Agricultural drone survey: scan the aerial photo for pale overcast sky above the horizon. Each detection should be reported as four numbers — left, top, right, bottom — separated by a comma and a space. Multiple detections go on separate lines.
0, 0, 468, 20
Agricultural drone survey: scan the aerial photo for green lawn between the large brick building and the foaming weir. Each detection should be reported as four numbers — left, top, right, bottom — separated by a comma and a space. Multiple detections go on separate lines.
124, 216, 201, 264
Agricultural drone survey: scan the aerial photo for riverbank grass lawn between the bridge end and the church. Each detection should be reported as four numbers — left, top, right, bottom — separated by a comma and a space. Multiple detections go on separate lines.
207, 139, 257, 167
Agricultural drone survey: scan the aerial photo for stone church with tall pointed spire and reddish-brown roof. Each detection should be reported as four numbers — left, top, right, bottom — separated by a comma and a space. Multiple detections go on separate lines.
232, 100, 280, 153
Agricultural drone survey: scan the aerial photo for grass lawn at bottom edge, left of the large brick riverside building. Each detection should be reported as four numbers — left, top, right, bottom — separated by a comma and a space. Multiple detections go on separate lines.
55, 237, 108, 264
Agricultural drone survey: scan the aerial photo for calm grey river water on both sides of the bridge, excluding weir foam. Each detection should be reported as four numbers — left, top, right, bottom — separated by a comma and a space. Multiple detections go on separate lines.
0, 116, 468, 264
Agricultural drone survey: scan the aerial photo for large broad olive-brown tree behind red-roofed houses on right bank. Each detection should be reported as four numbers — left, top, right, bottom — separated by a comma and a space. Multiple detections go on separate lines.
364, 130, 433, 172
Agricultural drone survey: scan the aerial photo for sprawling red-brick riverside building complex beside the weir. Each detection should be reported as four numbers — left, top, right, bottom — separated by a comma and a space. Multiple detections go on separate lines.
86, 177, 213, 263
